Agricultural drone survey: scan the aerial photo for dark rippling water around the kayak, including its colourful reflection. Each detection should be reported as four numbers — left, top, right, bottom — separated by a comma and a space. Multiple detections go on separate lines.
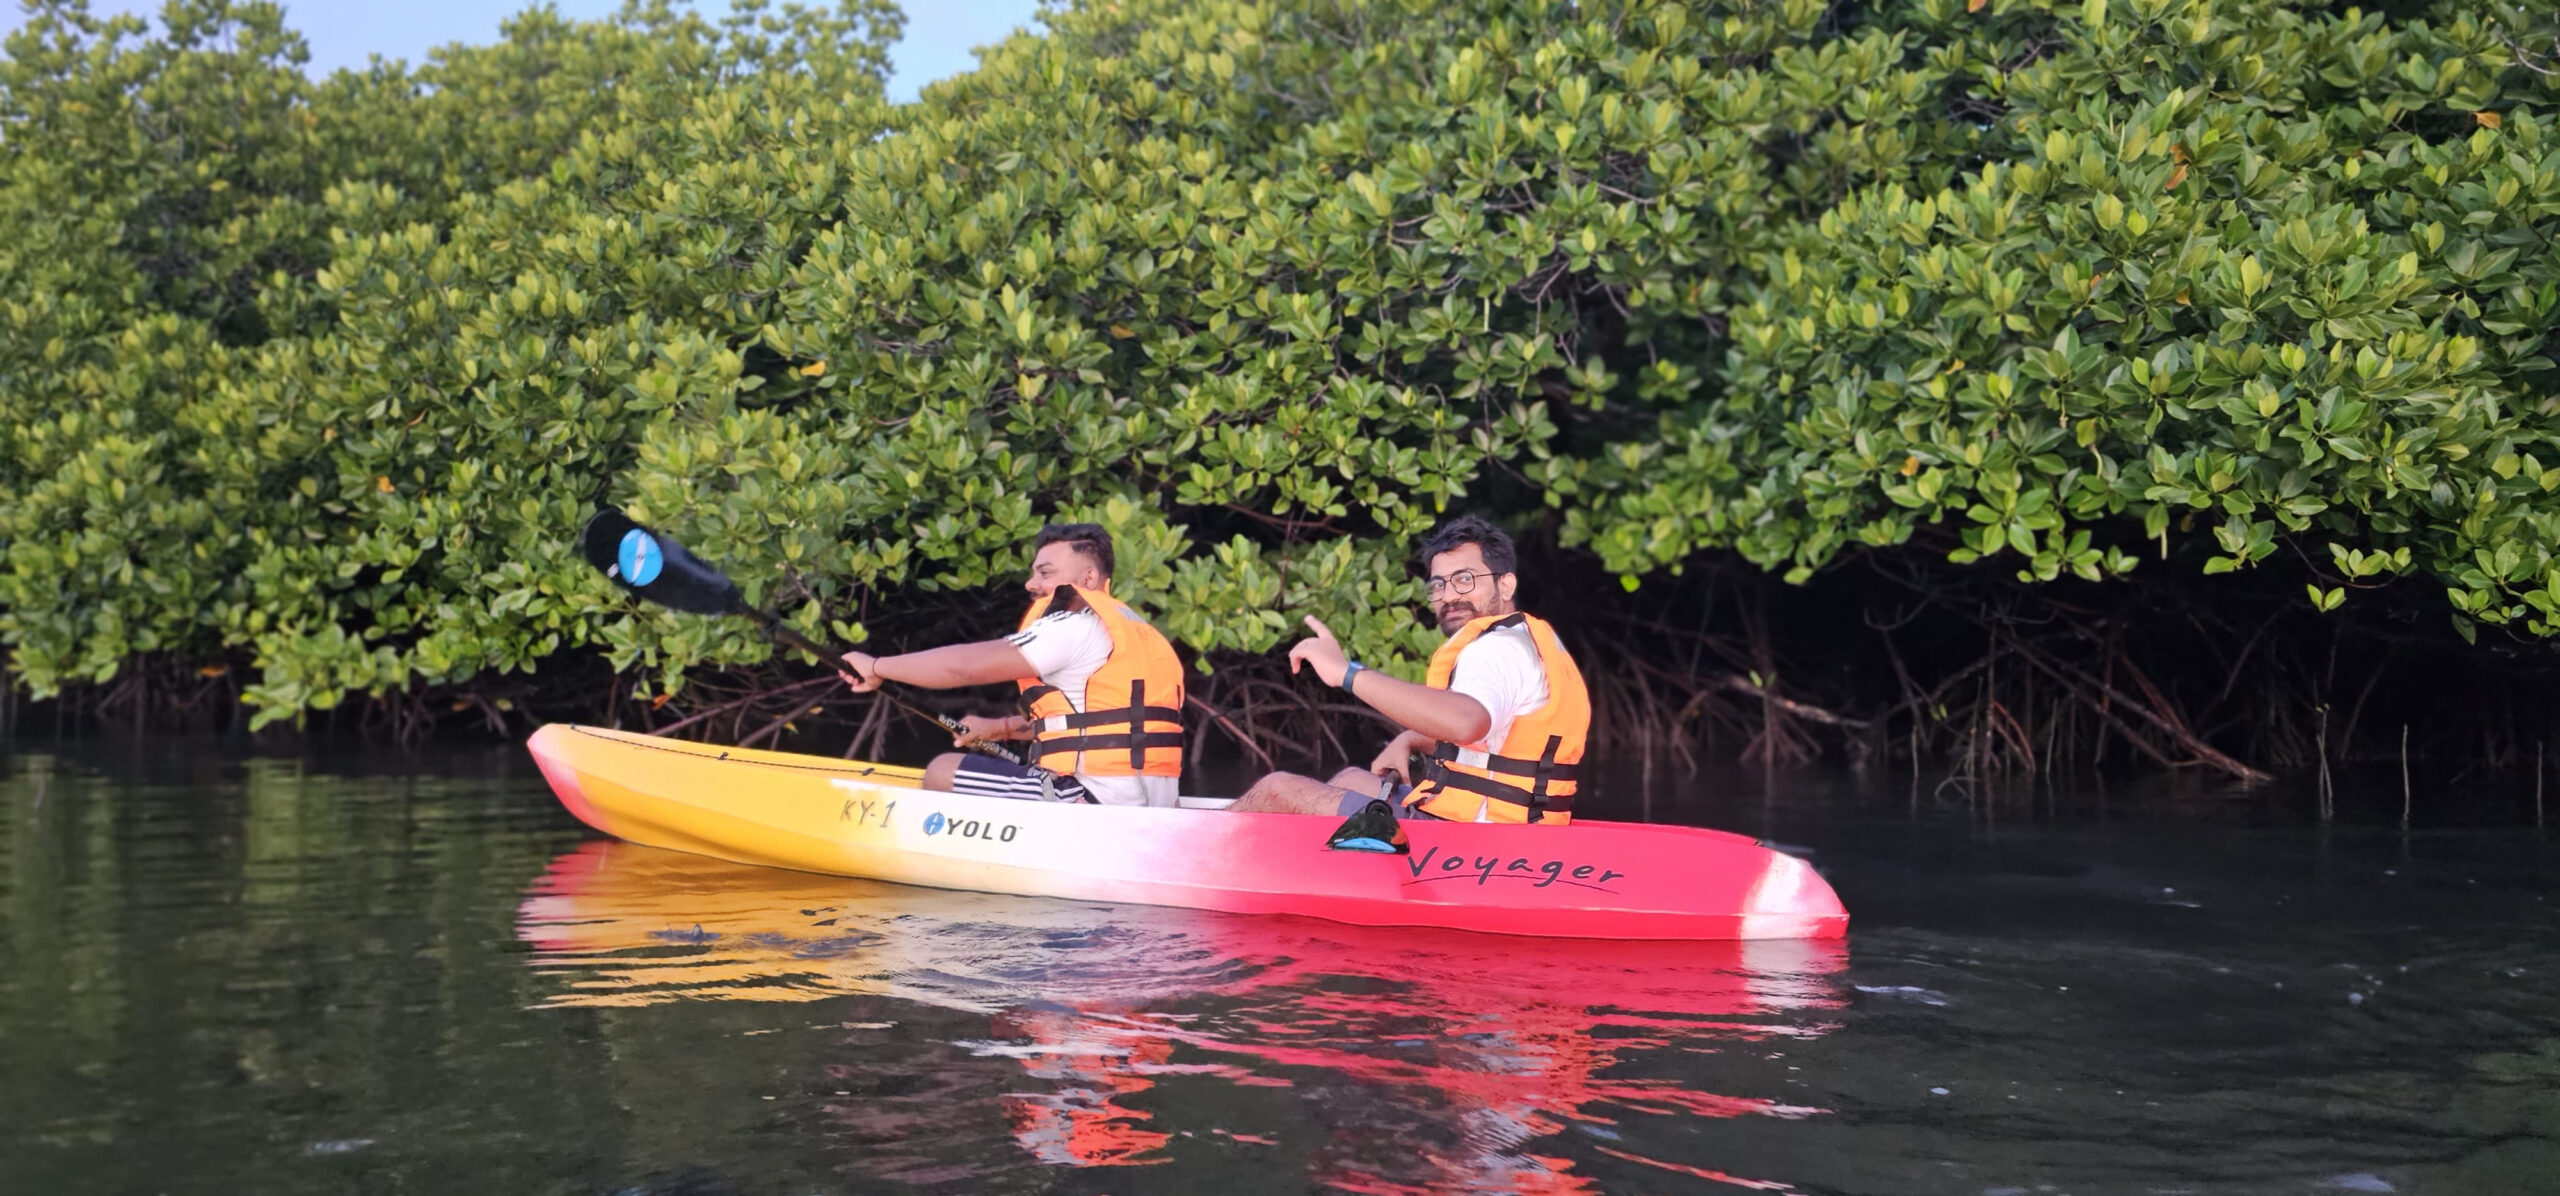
0, 745, 2560, 1196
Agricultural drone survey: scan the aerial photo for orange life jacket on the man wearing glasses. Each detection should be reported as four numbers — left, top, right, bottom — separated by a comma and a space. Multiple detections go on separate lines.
1413, 612, 1592, 827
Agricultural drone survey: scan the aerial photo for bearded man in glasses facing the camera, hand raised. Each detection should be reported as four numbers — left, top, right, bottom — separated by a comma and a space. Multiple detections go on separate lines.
1231, 515, 1590, 827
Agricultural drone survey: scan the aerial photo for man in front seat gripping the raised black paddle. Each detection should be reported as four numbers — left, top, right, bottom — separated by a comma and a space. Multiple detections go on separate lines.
845, 522, 1183, 807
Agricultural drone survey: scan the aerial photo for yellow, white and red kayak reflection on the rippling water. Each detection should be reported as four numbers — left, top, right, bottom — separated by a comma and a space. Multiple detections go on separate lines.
520, 843, 1846, 1193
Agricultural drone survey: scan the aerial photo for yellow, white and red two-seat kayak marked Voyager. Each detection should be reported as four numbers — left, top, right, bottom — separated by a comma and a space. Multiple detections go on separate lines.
527, 725, 1848, 940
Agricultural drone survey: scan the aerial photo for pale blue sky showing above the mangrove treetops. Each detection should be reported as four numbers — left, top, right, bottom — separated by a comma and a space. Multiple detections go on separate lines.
0, 0, 1039, 102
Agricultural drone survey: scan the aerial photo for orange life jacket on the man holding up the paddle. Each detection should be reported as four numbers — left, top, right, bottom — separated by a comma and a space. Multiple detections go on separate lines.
1016, 586, 1183, 776
